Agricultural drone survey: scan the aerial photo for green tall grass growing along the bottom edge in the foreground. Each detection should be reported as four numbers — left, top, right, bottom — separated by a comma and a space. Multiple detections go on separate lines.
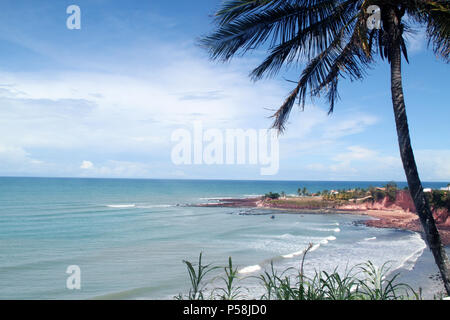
177, 244, 422, 300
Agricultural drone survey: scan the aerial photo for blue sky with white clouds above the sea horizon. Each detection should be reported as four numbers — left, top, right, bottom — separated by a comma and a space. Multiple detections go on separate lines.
0, 0, 450, 182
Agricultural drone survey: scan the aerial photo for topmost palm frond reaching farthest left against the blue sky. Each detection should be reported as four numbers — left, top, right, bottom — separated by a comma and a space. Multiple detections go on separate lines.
200, 0, 362, 61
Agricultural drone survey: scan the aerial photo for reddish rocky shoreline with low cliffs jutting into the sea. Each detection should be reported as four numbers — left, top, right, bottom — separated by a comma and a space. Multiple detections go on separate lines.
192, 197, 450, 246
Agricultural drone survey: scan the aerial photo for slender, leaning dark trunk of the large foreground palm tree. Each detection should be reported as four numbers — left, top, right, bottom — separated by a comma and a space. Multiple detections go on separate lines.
387, 10, 450, 295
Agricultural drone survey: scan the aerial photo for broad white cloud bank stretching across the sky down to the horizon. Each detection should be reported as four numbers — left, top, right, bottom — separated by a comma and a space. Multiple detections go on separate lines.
0, 36, 444, 180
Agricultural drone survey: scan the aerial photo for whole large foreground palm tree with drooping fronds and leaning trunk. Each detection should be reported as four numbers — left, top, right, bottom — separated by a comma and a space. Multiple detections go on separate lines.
201, 0, 450, 294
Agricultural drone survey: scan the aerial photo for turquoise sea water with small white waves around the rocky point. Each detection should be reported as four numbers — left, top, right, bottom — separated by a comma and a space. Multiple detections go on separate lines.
0, 178, 446, 299
